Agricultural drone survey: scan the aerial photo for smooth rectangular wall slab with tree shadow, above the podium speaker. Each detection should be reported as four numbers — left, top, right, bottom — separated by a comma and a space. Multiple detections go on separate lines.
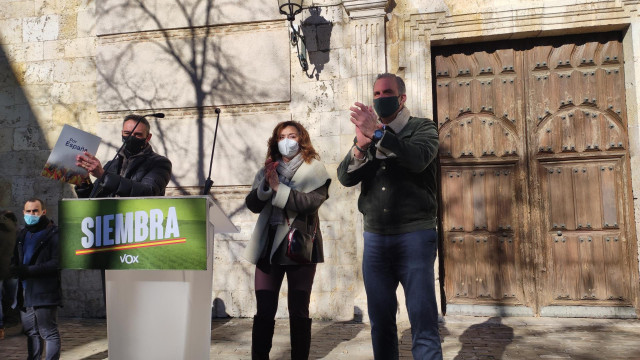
97, 27, 289, 111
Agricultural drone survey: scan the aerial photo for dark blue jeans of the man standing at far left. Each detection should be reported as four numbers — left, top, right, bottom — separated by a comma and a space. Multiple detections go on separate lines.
20, 306, 60, 360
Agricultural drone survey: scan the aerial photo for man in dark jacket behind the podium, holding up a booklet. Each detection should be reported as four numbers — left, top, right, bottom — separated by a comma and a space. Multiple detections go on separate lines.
75, 115, 171, 198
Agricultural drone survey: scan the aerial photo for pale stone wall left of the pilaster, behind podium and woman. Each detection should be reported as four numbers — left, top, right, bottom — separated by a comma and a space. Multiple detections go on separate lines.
0, 0, 364, 319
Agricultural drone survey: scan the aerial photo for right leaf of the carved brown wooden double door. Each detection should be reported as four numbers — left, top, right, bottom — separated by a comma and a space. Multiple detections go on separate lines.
524, 34, 637, 308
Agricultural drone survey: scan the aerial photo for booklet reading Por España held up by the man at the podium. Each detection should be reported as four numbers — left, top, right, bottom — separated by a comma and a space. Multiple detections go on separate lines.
41, 125, 100, 185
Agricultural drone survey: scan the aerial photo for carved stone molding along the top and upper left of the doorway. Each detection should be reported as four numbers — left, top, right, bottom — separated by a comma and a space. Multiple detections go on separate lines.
396, 0, 640, 117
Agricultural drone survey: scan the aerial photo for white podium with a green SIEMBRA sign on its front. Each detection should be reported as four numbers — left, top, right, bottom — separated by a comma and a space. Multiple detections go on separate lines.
60, 196, 238, 360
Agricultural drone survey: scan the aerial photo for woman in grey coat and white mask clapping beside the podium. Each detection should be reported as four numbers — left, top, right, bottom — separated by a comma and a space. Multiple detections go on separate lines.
244, 121, 331, 360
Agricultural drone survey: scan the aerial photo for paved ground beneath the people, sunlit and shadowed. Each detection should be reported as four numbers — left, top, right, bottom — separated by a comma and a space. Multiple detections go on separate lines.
0, 316, 640, 360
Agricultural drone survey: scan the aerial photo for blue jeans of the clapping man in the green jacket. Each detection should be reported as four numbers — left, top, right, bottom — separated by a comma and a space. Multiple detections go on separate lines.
362, 229, 442, 360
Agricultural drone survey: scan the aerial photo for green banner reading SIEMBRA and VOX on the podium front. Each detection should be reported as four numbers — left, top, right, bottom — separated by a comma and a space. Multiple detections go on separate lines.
59, 198, 207, 270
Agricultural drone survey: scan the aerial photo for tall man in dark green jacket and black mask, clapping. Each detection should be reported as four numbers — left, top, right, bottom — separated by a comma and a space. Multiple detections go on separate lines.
338, 73, 442, 360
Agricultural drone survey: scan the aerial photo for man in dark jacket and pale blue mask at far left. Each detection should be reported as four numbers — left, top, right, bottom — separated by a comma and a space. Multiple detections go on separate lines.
10, 198, 62, 360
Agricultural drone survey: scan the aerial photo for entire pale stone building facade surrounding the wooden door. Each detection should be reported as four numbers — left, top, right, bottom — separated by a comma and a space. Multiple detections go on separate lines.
0, 0, 640, 320
